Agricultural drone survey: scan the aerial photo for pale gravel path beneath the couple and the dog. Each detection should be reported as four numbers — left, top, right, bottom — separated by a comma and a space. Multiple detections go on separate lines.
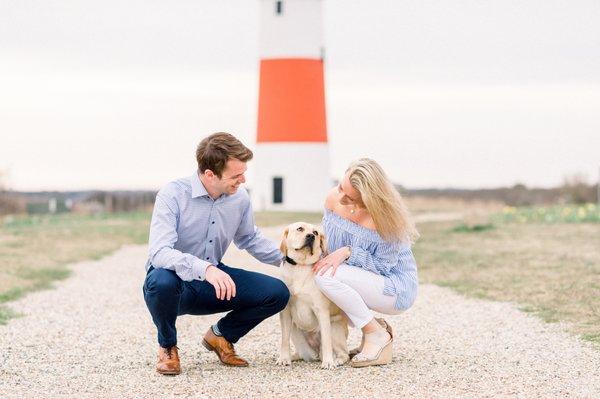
0, 229, 600, 398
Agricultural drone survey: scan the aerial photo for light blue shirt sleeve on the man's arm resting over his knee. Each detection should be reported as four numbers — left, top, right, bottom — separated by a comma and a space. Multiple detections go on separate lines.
149, 193, 211, 281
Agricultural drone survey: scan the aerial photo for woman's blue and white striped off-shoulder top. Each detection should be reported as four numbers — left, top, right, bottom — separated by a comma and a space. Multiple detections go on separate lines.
323, 209, 419, 310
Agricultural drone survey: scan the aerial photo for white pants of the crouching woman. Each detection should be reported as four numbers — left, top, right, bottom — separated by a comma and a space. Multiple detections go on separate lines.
315, 263, 402, 328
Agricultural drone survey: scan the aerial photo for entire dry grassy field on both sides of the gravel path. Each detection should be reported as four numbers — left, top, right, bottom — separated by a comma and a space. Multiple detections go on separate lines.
0, 205, 600, 345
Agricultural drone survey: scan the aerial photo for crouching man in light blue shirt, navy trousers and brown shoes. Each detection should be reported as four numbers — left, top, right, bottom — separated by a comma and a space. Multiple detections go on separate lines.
143, 133, 289, 374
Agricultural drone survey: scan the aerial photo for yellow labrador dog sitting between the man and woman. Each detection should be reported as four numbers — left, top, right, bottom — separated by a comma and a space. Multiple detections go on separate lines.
277, 222, 349, 369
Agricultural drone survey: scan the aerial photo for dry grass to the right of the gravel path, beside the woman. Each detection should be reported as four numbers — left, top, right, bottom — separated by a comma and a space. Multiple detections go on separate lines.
415, 217, 600, 345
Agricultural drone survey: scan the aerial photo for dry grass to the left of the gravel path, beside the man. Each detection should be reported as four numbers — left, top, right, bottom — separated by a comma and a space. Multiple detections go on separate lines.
0, 213, 150, 324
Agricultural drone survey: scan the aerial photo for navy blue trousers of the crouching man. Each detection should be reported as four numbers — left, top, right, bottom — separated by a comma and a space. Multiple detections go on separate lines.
143, 263, 290, 348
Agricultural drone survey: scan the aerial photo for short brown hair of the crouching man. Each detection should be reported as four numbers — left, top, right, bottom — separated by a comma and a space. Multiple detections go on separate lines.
196, 132, 253, 179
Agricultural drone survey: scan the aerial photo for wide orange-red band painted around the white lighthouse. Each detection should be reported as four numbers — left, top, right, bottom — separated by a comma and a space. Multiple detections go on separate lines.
256, 58, 327, 143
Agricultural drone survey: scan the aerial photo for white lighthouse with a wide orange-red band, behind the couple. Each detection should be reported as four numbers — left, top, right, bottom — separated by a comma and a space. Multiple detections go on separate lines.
251, 0, 332, 211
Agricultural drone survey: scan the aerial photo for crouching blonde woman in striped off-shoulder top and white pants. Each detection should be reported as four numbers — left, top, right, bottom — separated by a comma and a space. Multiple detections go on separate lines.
313, 158, 418, 367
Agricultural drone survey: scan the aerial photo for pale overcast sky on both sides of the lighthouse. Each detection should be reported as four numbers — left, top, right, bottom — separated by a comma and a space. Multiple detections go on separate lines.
0, 0, 600, 190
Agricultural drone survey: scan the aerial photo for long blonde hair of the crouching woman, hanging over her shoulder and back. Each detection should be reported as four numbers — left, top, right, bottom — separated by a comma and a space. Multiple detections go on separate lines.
346, 158, 419, 243
